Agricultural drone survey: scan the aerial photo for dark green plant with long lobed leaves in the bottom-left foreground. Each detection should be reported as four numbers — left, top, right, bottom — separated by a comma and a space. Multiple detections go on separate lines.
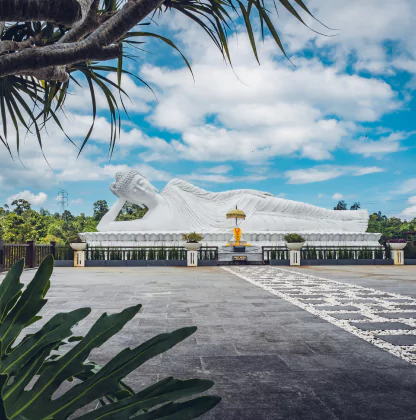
0, 255, 220, 420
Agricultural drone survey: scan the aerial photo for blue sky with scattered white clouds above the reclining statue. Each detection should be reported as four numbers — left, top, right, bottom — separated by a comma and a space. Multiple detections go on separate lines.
0, 0, 416, 220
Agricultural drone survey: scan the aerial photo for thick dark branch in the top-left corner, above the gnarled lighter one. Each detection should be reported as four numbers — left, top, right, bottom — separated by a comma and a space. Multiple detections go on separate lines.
0, 0, 92, 26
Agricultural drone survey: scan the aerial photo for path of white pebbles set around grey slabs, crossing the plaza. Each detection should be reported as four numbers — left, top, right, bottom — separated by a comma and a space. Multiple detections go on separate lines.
222, 266, 416, 365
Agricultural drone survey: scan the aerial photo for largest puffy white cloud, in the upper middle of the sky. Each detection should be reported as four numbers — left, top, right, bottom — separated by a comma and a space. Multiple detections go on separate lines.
137, 25, 400, 163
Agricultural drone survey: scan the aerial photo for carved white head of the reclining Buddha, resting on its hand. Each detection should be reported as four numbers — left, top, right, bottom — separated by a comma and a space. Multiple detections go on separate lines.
110, 169, 158, 207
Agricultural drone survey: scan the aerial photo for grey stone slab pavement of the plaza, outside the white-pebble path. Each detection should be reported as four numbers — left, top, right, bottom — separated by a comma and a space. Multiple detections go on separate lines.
12, 267, 416, 420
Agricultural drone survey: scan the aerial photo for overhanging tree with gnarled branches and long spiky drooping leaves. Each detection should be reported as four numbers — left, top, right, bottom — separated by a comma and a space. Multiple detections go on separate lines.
0, 0, 329, 153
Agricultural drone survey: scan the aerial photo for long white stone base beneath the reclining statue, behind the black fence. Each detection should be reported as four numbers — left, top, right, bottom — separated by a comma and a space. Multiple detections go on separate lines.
79, 231, 381, 247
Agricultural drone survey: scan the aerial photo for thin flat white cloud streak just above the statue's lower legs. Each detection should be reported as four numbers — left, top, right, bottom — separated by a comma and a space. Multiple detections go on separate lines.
284, 165, 384, 184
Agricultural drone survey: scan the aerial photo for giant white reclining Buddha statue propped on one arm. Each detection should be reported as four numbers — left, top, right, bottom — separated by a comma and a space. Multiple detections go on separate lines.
97, 170, 368, 233
